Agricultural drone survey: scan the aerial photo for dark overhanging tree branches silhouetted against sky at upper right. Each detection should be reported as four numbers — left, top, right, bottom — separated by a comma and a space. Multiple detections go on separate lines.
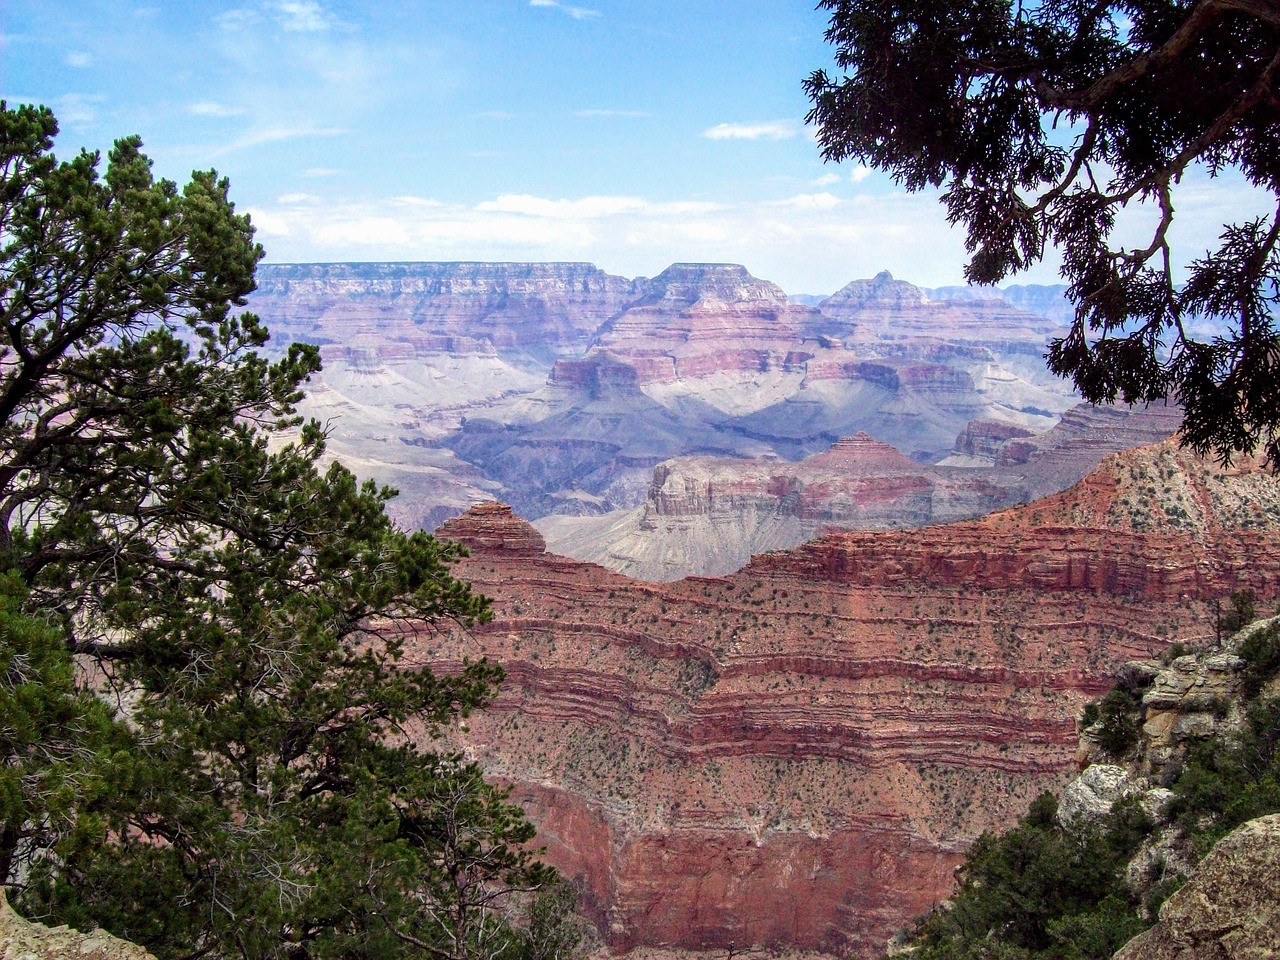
806, 0, 1280, 462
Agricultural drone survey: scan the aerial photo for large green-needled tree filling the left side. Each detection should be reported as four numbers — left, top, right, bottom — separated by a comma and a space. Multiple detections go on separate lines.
0, 102, 581, 960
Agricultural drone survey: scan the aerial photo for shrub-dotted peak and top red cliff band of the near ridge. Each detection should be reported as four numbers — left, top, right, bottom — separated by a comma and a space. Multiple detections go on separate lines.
744, 442, 1280, 603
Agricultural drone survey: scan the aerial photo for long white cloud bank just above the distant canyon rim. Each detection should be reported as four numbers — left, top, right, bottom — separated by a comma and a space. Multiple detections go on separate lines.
247, 192, 977, 293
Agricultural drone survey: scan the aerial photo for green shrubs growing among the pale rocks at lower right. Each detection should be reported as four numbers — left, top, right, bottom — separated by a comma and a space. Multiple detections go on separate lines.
910, 625, 1280, 960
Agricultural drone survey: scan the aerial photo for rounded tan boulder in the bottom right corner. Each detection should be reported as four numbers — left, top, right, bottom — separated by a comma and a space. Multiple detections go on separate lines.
1115, 814, 1280, 960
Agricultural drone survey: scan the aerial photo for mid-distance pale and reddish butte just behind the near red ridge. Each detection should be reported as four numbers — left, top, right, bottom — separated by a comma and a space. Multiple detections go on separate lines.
538, 404, 1180, 581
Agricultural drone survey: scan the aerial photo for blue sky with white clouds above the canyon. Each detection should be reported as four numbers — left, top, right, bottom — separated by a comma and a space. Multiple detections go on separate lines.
0, 0, 1264, 294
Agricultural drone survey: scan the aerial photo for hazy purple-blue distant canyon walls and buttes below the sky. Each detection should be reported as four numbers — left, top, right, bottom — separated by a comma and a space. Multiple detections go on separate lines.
251, 262, 1126, 570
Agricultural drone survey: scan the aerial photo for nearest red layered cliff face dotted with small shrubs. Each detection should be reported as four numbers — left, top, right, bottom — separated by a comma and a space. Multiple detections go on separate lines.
411, 448, 1280, 956
